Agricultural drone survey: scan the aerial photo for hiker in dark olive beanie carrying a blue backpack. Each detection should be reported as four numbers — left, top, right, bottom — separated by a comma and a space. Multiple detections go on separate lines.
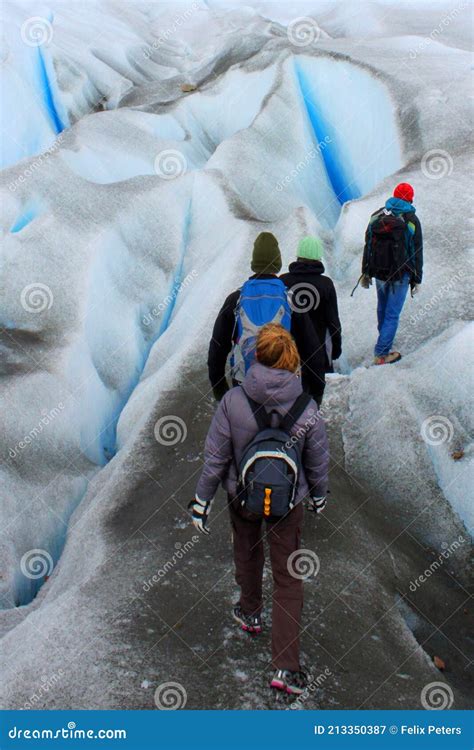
207, 232, 325, 402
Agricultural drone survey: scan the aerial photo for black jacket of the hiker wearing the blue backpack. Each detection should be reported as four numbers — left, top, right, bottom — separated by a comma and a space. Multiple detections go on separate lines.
207, 273, 325, 399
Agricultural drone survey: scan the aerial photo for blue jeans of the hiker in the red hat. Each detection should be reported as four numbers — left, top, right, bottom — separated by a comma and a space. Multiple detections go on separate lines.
374, 273, 410, 357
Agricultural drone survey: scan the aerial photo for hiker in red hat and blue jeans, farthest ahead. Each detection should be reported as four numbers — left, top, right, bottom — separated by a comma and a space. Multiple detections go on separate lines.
360, 182, 423, 365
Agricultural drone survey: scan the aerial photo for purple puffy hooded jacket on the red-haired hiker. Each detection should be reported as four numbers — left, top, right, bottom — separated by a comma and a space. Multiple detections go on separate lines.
196, 363, 329, 503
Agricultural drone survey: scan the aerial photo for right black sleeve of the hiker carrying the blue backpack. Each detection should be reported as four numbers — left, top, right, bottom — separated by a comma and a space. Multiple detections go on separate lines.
291, 312, 326, 398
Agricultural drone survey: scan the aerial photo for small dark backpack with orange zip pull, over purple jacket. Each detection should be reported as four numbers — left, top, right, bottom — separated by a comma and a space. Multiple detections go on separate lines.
238, 389, 311, 518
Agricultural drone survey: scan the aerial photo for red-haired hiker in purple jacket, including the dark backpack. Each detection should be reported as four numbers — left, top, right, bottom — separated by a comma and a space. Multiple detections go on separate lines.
190, 323, 329, 694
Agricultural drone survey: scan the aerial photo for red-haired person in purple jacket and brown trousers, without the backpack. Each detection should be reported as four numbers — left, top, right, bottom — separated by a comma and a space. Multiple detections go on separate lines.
190, 323, 329, 694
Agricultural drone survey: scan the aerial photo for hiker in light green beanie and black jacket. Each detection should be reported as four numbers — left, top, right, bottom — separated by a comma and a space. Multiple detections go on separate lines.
280, 237, 341, 382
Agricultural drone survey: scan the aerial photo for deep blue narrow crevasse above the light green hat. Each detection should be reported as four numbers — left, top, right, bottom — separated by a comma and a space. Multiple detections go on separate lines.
295, 60, 361, 205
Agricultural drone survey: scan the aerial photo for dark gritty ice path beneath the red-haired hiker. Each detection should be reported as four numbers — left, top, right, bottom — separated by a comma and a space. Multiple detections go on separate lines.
0, 368, 471, 709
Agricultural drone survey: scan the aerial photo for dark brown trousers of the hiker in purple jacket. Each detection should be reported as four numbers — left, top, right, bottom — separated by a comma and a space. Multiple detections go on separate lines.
229, 497, 303, 671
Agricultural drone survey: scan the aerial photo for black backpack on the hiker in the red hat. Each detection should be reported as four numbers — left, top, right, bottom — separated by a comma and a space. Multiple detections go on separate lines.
368, 208, 408, 281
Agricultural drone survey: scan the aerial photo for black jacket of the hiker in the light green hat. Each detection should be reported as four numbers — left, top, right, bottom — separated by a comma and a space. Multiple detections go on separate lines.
280, 260, 341, 372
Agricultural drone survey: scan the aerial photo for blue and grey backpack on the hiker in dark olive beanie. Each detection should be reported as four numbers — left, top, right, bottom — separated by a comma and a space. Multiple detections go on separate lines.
231, 277, 291, 383
